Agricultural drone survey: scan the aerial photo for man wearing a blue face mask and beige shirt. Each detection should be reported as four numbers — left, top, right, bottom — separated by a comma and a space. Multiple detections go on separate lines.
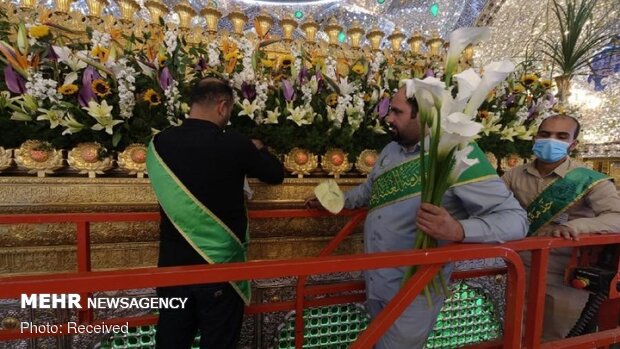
502, 115, 620, 340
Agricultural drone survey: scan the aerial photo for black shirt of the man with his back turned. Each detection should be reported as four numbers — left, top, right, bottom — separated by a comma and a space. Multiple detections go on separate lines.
154, 119, 284, 266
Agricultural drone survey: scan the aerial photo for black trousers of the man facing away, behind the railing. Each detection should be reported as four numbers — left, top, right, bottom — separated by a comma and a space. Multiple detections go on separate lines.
155, 283, 244, 349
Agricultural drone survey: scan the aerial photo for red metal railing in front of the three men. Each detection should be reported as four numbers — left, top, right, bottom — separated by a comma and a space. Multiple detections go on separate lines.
0, 210, 620, 348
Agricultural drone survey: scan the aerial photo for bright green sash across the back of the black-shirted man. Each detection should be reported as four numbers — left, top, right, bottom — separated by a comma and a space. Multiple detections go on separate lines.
146, 141, 250, 304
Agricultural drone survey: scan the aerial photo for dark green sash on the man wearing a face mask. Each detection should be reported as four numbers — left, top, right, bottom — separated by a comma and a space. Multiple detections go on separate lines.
527, 167, 609, 236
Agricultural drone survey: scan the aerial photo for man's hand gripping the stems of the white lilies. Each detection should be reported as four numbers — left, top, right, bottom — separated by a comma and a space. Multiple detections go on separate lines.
416, 203, 465, 241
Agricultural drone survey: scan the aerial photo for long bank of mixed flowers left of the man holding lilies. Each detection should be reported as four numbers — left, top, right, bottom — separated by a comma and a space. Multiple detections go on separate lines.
0, 14, 400, 158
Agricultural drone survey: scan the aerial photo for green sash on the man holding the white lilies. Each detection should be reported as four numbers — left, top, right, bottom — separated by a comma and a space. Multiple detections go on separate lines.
368, 143, 498, 210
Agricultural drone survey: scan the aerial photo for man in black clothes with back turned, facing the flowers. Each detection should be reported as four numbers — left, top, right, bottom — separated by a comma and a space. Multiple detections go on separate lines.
147, 78, 284, 349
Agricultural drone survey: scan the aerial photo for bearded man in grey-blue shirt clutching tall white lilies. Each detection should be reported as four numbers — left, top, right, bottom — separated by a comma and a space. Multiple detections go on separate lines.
307, 80, 527, 349
